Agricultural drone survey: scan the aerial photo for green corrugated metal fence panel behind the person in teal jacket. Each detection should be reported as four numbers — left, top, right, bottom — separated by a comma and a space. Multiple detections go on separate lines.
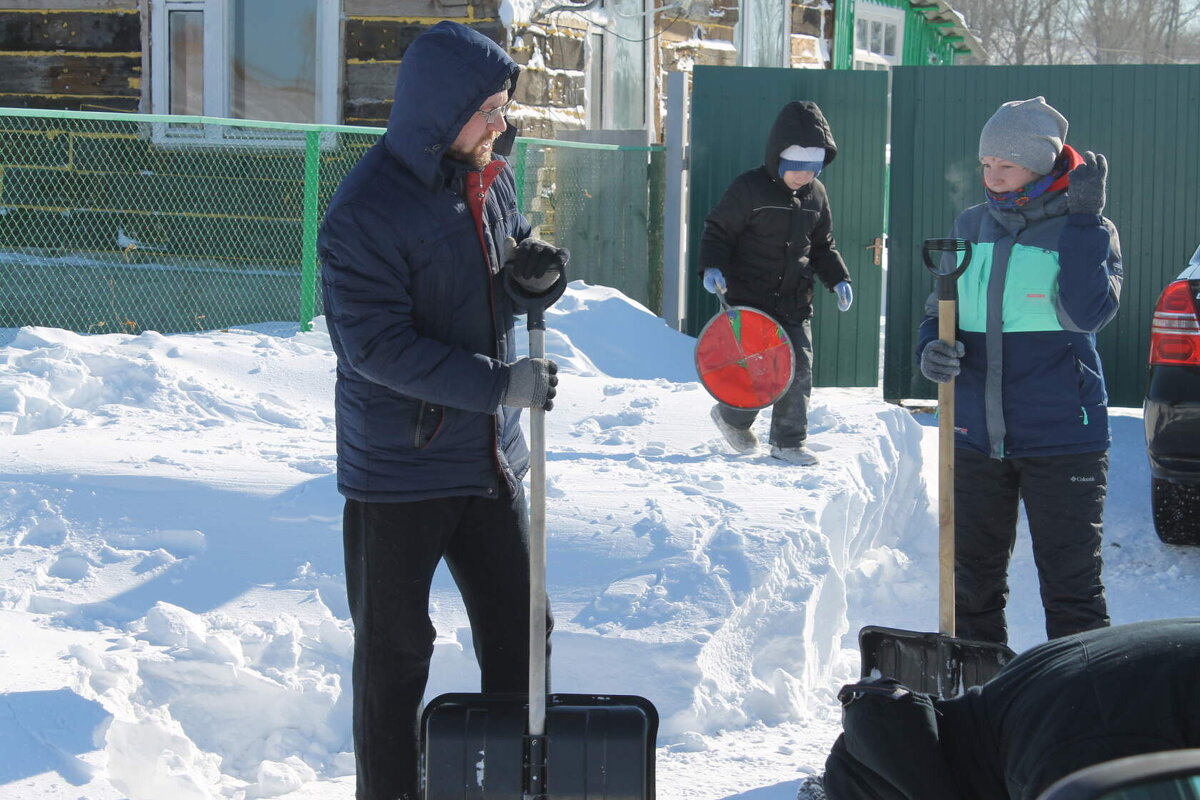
883, 65, 1200, 407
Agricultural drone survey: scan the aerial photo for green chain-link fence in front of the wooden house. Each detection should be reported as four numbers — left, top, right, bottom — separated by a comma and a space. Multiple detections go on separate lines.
0, 109, 662, 333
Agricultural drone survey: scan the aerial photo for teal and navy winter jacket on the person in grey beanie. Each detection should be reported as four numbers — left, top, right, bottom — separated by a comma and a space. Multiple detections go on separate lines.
917, 154, 1122, 458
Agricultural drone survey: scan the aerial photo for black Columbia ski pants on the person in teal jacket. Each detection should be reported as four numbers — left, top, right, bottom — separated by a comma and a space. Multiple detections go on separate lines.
954, 447, 1109, 643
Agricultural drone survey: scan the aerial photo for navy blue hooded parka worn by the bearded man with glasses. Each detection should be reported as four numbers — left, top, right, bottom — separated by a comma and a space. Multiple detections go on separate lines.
318, 22, 529, 503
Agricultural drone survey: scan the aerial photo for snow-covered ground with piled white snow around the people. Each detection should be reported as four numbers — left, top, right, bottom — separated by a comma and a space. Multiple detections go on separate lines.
0, 283, 1200, 800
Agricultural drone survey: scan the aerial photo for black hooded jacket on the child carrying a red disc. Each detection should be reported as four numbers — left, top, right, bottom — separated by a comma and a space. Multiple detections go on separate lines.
700, 102, 850, 321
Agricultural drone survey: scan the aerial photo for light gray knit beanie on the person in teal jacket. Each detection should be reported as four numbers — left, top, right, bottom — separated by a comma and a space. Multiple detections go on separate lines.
979, 96, 1067, 175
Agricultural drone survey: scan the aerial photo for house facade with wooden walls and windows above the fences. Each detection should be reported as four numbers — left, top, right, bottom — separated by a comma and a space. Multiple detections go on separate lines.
0, 0, 979, 142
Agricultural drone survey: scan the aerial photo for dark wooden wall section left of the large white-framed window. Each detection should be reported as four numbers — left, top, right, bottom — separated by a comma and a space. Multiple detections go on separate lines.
0, 0, 145, 112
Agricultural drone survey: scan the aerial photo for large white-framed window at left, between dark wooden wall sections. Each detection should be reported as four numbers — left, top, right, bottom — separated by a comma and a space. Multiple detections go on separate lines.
150, 0, 338, 122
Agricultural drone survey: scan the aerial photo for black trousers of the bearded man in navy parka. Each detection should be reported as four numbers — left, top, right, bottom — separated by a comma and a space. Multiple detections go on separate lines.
342, 482, 552, 800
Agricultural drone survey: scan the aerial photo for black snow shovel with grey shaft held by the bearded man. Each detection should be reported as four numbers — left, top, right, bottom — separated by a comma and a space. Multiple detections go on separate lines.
421, 253, 659, 800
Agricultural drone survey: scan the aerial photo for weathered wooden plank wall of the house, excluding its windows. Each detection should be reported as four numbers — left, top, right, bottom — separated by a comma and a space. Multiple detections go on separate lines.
0, 0, 833, 140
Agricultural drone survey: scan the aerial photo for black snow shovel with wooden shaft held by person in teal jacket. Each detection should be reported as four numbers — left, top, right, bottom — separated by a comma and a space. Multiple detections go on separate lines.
858, 239, 1015, 698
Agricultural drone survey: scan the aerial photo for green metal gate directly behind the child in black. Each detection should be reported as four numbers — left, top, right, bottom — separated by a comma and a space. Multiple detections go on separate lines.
686, 66, 887, 386
